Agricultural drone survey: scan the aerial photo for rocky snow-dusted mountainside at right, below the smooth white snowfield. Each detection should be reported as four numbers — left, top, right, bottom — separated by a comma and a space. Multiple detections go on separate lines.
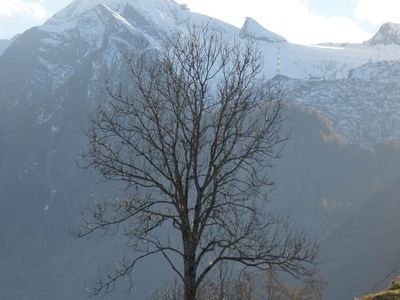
272, 61, 400, 144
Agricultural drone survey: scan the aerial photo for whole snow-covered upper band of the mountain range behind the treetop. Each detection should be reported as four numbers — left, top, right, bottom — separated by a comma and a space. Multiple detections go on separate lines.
0, 0, 400, 142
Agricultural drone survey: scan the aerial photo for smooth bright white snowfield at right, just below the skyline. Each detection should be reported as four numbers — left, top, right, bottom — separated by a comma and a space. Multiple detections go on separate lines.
258, 42, 400, 79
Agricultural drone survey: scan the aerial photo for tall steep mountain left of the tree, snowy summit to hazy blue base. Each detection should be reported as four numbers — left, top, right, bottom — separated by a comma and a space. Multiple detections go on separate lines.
0, 0, 225, 300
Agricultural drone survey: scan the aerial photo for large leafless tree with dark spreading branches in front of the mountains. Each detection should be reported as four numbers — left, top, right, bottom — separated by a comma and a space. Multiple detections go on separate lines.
77, 26, 316, 300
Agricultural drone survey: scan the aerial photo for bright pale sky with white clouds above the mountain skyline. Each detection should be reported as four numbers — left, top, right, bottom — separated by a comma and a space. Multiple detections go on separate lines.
0, 0, 400, 44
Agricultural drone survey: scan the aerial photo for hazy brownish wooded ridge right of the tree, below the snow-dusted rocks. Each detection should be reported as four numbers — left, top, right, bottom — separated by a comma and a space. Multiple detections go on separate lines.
271, 105, 400, 238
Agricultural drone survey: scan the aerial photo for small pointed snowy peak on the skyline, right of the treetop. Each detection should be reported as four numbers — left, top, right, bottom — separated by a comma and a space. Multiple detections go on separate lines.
240, 17, 286, 43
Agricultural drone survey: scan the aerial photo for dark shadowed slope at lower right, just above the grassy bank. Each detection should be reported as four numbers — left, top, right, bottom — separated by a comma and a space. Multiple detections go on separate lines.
320, 183, 400, 300
